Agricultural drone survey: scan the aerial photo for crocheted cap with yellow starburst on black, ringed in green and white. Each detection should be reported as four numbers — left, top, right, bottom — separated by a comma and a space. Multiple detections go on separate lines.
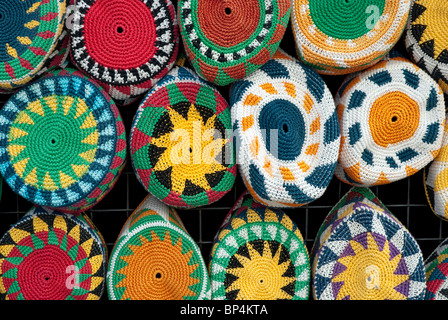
209, 194, 310, 300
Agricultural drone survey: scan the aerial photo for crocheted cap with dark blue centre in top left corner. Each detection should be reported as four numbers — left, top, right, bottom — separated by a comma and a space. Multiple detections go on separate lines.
0, 0, 66, 91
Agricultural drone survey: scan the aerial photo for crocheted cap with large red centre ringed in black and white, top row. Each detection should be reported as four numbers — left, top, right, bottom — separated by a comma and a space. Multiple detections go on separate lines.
71, 0, 179, 105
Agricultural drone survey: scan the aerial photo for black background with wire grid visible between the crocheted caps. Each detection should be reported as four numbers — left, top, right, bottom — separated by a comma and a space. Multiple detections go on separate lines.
0, 1, 448, 299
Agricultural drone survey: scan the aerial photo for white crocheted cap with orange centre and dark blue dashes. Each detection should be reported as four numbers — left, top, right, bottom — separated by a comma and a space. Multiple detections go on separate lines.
335, 58, 445, 186
